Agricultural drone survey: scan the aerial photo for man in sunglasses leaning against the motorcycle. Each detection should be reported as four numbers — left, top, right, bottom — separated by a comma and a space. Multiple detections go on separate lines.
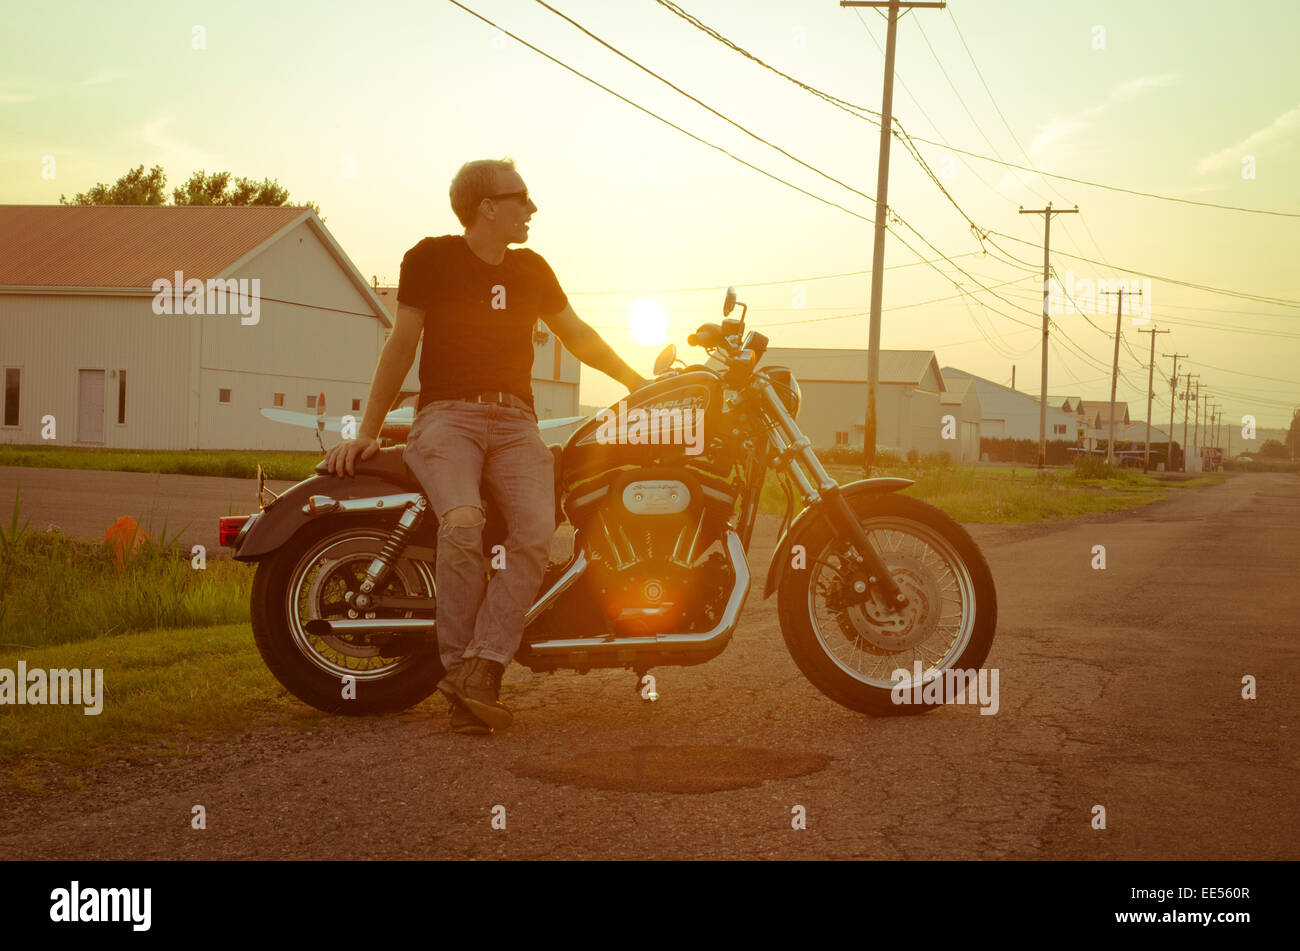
326, 159, 646, 734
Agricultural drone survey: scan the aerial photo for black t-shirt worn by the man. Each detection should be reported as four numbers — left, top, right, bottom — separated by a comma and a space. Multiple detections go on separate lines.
398, 234, 568, 408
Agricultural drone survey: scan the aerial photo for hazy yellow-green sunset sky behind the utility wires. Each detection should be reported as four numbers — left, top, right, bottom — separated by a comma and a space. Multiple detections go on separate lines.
0, 0, 1300, 426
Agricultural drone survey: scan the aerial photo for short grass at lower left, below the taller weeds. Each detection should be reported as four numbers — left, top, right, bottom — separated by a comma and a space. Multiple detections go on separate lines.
0, 624, 325, 793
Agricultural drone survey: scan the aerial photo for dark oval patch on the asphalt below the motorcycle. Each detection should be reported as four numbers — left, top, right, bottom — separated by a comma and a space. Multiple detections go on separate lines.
514, 746, 831, 793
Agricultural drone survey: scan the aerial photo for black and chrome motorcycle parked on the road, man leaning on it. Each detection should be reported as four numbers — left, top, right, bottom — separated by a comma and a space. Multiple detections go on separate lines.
221, 288, 997, 715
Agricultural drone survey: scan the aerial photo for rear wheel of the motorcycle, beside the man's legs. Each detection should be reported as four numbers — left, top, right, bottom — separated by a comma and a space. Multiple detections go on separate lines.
252, 517, 443, 716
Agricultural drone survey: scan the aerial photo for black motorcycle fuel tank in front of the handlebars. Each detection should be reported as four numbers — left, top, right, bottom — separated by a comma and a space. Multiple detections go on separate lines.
562, 369, 735, 488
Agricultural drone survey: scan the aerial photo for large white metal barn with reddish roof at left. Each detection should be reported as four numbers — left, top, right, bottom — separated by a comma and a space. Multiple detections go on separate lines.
0, 205, 577, 451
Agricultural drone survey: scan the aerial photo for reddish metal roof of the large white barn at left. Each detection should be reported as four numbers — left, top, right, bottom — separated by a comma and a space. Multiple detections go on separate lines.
0, 205, 308, 287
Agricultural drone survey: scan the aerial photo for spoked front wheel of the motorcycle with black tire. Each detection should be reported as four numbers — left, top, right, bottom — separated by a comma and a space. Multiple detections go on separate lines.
777, 495, 997, 716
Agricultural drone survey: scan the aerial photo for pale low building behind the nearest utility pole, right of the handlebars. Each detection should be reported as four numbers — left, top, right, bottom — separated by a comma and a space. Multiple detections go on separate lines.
762, 347, 956, 455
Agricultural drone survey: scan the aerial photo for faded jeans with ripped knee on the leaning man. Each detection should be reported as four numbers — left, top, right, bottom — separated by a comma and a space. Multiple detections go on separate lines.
403, 400, 555, 670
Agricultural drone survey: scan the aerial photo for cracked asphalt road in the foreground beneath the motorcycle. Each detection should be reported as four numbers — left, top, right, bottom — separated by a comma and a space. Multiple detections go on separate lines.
0, 474, 1300, 857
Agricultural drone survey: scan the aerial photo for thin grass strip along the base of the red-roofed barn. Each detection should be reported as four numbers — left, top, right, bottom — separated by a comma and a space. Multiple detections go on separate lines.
0, 446, 322, 482
